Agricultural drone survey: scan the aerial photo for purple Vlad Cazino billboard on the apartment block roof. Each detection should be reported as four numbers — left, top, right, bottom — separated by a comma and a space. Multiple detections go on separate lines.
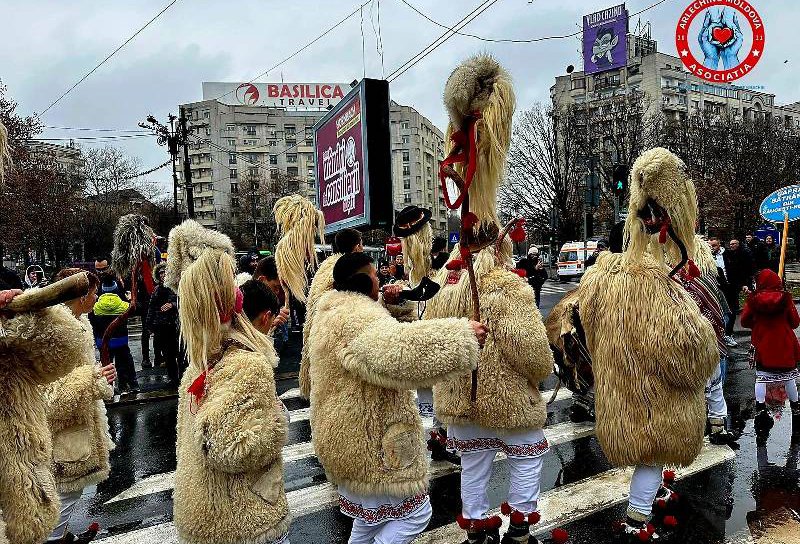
583, 4, 628, 75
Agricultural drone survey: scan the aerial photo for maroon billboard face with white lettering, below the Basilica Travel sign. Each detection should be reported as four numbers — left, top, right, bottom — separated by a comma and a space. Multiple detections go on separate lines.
314, 92, 369, 232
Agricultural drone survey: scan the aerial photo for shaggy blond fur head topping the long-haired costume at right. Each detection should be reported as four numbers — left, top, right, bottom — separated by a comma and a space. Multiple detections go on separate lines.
625, 147, 698, 272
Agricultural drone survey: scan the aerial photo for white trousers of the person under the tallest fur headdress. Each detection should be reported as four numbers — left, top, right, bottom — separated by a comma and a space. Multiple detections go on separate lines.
461, 450, 543, 519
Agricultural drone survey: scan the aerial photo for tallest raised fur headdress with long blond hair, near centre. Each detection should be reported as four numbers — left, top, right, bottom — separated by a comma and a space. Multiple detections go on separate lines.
444, 54, 516, 223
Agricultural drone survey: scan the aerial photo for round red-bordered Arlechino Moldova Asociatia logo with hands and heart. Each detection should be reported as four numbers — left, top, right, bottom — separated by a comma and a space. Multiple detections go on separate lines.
675, 0, 765, 83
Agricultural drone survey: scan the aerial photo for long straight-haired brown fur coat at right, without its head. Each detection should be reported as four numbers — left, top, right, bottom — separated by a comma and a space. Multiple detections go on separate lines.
580, 252, 719, 466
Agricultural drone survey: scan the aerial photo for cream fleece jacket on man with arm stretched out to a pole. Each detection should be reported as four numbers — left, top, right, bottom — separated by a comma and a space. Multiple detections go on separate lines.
310, 290, 479, 497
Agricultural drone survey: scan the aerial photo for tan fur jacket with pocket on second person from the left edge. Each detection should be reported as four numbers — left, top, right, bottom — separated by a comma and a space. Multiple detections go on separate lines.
44, 316, 114, 493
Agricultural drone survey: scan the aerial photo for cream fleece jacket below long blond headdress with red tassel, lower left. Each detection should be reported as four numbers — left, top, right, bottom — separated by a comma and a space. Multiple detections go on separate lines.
174, 346, 290, 544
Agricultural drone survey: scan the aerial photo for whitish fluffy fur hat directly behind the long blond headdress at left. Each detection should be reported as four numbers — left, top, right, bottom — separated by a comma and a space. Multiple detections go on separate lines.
164, 219, 235, 291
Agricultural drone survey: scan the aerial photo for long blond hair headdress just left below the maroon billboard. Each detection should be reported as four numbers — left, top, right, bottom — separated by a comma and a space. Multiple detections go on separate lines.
273, 195, 325, 302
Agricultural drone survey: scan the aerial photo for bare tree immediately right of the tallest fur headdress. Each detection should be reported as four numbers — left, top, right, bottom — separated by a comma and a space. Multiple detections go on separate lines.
499, 104, 586, 246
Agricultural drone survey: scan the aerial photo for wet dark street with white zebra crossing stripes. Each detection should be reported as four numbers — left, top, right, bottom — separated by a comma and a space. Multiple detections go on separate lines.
62, 281, 800, 544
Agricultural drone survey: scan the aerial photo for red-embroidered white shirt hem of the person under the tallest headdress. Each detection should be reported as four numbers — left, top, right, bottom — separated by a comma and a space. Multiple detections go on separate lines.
447, 425, 550, 457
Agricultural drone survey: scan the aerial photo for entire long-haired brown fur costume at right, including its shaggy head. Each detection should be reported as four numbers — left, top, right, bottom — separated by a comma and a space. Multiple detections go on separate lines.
580, 148, 719, 465
